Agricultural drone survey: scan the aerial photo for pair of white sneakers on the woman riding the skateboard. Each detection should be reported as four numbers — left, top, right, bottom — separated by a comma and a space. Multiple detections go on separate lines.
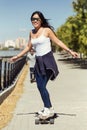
39, 107, 54, 119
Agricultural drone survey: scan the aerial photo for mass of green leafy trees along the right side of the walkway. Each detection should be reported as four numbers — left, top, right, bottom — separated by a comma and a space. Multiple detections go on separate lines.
56, 0, 87, 55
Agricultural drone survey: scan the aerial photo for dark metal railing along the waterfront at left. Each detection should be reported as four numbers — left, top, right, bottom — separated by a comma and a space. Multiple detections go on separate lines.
0, 56, 26, 92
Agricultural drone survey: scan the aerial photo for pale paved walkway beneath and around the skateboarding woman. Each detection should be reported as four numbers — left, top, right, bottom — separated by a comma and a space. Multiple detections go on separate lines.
2, 54, 87, 130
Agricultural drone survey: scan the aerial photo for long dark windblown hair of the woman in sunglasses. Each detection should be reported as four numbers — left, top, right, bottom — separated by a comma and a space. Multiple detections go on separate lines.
31, 11, 54, 30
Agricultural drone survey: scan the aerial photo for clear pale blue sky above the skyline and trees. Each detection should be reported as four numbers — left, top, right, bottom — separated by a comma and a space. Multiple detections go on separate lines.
0, 0, 74, 43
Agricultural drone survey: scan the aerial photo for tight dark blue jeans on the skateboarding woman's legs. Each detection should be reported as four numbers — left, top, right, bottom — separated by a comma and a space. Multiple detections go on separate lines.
35, 70, 52, 108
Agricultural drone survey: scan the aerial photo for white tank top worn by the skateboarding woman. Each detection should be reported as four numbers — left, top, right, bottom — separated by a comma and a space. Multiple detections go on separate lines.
31, 31, 51, 56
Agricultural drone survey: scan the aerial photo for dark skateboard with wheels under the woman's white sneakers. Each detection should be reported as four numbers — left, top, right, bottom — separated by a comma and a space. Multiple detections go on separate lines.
35, 113, 57, 125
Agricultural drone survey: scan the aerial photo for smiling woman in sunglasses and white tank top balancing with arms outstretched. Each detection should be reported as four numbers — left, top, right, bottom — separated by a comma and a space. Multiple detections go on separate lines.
11, 11, 78, 118
